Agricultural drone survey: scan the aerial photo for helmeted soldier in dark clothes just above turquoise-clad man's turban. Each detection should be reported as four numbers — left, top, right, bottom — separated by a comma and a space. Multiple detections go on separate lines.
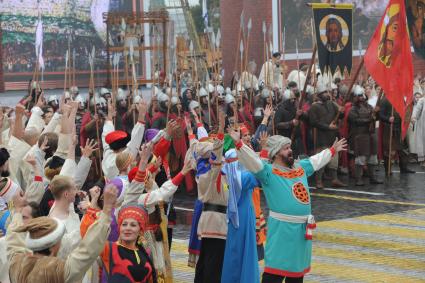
274, 85, 307, 158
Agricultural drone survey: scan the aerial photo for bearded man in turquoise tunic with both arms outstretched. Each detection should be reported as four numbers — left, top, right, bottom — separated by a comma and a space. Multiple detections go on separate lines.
229, 129, 346, 283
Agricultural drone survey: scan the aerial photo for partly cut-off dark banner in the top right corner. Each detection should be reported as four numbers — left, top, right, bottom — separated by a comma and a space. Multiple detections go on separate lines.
406, 0, 425, 59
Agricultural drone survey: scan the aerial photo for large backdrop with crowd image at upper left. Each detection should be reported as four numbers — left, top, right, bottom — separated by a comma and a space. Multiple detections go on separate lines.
0, 0, 131, 76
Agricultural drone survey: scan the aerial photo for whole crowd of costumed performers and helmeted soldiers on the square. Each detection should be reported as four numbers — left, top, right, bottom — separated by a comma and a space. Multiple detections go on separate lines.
0, 51, 425, 283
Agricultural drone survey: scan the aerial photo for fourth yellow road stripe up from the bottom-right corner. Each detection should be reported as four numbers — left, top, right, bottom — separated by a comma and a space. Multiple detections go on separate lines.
317, 220, 425, 240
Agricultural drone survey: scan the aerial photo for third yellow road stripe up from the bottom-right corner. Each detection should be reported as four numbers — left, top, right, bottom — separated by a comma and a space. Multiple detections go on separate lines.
313, 232, 425, 255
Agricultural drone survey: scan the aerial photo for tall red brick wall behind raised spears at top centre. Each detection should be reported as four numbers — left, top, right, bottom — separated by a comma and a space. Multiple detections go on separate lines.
220, 0, 272, 84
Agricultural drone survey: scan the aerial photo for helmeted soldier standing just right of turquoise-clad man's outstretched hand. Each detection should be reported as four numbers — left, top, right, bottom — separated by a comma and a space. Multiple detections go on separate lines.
348, 85, 382, 186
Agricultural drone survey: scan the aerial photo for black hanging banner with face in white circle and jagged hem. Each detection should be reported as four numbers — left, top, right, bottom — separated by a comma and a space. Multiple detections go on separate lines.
312, 3, 353, 75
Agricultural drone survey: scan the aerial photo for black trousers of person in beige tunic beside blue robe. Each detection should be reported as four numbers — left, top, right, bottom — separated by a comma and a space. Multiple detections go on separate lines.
194, 238, 226, 283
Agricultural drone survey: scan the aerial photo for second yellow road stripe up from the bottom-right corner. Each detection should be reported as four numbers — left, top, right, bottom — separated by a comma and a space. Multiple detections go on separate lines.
313, 245, 425, 271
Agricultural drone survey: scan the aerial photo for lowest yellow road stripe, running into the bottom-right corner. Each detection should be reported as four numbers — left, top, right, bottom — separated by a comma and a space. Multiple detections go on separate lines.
312, 260, 424, 283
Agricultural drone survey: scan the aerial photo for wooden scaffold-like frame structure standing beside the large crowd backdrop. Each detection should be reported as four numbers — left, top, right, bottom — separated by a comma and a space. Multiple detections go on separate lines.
103, 10, 170, 89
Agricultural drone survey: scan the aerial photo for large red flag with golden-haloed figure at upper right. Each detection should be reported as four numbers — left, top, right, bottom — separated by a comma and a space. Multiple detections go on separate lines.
364, 0, 413, 138
